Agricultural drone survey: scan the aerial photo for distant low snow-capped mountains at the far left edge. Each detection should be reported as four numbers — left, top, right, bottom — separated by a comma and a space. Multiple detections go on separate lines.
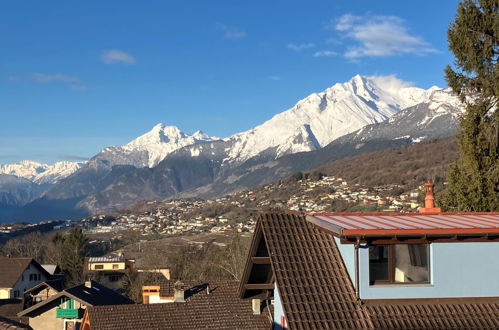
0, 160, 85, 184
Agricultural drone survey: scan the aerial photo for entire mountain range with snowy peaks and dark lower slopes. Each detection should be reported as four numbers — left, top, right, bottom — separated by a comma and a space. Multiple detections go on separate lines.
0, 75, 463, 221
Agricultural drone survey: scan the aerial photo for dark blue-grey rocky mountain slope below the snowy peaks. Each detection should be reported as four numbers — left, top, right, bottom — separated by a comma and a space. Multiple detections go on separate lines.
79, 84, 461, 212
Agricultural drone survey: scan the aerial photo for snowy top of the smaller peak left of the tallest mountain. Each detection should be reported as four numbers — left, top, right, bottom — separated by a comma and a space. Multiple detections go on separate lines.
90, 123, 218, 167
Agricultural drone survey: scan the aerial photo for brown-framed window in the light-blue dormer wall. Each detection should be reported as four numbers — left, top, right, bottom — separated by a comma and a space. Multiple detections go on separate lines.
369, 244, 430, 285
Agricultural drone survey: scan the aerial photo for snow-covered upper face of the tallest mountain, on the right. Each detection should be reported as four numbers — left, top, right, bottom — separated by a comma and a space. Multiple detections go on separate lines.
217, 75, 459, 163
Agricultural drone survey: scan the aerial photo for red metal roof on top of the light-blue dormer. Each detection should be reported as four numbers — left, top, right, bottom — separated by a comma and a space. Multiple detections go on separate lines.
308, 212, 499, 236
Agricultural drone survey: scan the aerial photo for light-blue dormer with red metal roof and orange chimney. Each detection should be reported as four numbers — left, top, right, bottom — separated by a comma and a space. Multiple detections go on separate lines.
307, 206, 499, 301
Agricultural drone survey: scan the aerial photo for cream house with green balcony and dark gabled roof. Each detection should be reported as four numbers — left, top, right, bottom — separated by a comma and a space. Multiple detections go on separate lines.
18, 281, 133, 330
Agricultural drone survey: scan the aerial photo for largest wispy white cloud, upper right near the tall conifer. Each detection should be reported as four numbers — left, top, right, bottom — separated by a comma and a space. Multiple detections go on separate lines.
334, 14, 436, 59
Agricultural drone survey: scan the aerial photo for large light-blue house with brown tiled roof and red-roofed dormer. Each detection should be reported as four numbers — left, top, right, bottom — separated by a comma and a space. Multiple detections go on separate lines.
239, 183, 499, 329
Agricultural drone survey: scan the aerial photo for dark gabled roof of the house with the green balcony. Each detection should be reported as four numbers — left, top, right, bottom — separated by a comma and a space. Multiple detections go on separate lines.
18, 281, 133, 316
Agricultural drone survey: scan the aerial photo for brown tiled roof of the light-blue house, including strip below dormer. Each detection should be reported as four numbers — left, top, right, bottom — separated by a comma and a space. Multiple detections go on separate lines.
240, 213, 499, 329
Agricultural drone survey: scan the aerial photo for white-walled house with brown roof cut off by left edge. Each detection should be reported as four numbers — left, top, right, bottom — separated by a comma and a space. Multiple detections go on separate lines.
0, 257, 50, 299
